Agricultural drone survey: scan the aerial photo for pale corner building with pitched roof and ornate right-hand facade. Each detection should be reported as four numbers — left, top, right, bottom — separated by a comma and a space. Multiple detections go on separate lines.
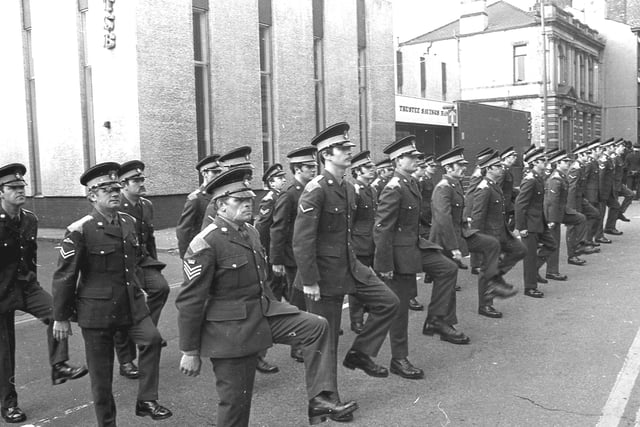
400, 0, 605, 150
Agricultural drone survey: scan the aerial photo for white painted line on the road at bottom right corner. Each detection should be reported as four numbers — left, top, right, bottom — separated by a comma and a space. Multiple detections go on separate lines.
596, 329, 640, 427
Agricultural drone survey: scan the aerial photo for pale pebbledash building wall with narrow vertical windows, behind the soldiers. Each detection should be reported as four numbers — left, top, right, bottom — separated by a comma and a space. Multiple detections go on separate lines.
0, 0, 395, 228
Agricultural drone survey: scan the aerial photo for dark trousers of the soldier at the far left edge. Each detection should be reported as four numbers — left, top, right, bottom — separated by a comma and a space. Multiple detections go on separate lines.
0, 285, 69, 408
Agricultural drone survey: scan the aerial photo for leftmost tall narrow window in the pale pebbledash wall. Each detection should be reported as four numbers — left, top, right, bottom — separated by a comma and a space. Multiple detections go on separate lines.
22, 0, 42, 195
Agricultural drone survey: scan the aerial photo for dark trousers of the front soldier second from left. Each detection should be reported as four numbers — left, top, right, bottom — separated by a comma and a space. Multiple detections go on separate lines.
82, 316, 162, 427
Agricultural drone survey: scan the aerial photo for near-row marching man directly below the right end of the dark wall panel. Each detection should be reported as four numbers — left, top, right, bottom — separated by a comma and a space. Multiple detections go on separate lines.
514, 145, 556, 298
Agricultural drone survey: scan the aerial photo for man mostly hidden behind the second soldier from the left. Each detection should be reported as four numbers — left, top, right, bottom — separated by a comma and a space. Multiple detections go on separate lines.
116, 160, 169, 379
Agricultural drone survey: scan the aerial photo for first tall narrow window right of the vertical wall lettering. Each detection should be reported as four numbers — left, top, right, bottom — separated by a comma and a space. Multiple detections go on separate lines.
192, 0, 213, 158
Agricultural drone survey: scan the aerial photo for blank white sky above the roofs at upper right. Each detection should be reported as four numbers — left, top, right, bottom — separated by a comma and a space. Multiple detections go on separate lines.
391, 0, 535, 42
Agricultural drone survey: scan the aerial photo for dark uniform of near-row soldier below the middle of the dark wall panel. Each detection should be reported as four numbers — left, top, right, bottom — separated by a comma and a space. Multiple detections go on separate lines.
470, 177, 527, 305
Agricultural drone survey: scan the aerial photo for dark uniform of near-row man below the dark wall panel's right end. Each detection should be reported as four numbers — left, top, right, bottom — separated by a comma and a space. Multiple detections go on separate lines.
514, 170, 557, 289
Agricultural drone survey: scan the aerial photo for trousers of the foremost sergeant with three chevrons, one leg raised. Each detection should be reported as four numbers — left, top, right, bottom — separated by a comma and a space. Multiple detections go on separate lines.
211, 312, 338, 427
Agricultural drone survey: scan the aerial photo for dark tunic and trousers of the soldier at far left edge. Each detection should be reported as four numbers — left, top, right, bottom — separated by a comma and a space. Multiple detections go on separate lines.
0, 206, 68, 408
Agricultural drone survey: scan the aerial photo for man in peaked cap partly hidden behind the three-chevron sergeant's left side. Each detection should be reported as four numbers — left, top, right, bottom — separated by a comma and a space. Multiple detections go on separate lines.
176, 154, 222, 258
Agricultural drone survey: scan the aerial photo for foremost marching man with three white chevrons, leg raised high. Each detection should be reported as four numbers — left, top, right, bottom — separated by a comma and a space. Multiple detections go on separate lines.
176, 166, 358, 426
